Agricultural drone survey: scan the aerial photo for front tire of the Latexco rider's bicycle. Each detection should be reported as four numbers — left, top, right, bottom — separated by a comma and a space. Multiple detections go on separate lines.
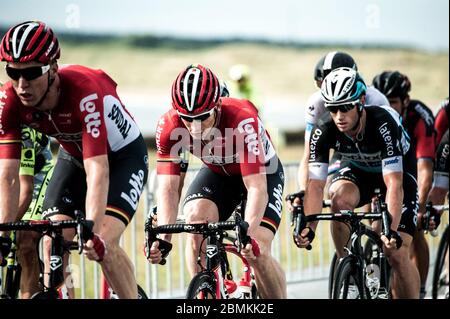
333, 256, 368, 299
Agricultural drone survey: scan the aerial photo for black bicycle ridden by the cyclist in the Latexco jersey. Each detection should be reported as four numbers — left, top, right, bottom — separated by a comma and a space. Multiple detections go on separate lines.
293, 192, 391, 299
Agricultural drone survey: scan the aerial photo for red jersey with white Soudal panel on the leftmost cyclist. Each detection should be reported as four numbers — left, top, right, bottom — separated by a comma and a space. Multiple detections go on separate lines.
0, 65, 141, 158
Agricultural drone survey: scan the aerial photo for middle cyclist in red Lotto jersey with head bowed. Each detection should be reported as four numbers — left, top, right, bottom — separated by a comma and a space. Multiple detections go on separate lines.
147, 65, 287, 298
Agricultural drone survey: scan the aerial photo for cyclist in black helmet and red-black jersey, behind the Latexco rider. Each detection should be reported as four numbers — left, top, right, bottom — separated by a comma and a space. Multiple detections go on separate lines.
373, 71, 436, 298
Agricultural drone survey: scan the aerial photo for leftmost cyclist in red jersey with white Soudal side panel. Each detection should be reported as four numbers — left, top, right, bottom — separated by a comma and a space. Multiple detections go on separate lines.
0, 21, 148, 298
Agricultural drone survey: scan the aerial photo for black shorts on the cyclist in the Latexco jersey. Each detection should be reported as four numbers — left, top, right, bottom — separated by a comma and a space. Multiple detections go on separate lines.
331, 163, 419, 236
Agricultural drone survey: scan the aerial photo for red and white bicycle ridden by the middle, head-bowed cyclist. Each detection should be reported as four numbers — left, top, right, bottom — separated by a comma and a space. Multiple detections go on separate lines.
145, 206, 260, 299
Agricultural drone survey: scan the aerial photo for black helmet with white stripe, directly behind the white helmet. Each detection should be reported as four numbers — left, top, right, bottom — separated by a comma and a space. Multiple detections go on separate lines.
314, 51, 358, 82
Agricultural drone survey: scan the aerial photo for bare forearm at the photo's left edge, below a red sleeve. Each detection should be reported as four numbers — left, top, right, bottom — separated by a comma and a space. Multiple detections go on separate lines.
0, 159, 20, 229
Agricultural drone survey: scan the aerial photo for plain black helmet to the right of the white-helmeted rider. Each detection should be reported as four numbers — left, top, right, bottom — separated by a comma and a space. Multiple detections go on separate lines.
372, 71, 411, 100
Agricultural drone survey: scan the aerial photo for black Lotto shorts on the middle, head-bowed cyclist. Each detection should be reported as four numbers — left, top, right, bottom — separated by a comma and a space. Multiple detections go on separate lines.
183, 159, 284, 234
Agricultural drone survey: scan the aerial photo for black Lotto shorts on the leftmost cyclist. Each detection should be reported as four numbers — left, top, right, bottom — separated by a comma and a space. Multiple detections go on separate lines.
42, 136, 148, 225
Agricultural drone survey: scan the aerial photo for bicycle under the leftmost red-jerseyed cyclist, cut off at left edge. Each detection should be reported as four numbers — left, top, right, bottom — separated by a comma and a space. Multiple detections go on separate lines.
0, 211, 94, 299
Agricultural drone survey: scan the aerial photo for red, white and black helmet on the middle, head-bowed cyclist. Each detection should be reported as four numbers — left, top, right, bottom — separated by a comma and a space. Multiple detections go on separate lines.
172, 64, 220, 115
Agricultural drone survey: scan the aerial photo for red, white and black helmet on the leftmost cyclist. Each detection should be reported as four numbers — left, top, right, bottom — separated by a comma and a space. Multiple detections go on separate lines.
0, 21, 60, 64
